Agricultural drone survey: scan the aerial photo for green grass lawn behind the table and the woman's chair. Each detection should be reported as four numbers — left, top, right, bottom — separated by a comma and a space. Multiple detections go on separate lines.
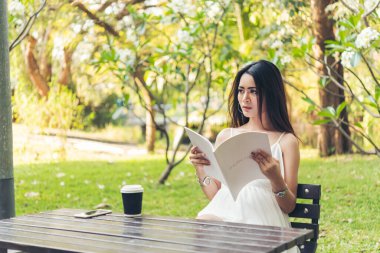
15, 155, 380, 252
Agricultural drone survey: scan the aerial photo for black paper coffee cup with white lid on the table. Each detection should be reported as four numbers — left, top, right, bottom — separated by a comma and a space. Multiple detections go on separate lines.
120, 185, 144, 217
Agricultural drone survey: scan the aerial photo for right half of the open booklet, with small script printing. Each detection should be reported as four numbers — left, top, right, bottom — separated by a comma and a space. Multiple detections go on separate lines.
214, 132, 272, 200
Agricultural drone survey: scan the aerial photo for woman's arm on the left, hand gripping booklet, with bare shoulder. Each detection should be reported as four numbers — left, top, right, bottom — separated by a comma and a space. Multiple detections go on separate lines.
190, 129, 229, 200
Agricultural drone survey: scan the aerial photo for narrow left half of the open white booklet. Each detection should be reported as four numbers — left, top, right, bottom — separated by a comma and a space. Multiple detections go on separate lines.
185, 127, 225, 184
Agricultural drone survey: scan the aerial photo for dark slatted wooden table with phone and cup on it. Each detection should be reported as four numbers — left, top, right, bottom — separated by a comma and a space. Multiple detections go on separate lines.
0, 209, 313, 253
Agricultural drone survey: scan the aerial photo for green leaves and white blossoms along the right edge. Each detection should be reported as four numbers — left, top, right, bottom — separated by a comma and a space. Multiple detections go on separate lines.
297, 1, 380, 156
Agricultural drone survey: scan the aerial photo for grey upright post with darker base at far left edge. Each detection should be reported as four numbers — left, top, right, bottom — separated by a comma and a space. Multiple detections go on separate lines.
0, 1, 15, 219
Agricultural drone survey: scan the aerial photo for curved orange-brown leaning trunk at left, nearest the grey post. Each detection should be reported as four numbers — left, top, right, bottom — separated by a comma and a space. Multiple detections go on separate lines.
25, 35, 49, 97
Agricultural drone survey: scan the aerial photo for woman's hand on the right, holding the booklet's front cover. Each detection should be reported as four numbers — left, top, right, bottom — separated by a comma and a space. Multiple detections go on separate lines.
251, 149, 282, 181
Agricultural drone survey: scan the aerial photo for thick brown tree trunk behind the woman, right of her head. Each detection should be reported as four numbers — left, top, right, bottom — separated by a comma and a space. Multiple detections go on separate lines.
311, 0, 350, 156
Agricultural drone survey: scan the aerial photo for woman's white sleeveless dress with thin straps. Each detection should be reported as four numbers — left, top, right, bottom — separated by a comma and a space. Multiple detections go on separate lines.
198, 128, 299, 253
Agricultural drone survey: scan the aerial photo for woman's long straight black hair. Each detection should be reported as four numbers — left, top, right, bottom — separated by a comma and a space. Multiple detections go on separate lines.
228, 60, 296, 136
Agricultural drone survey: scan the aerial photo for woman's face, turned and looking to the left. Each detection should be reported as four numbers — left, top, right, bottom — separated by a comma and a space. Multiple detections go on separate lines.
238, 74, 265, 118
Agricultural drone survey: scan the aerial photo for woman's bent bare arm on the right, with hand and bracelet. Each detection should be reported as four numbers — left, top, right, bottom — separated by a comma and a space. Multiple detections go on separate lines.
252, 134, 300, 213
